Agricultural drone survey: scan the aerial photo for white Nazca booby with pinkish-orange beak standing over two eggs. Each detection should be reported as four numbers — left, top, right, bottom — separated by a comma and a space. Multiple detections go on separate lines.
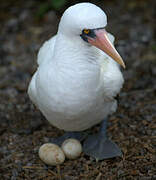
28, 3, 125, 159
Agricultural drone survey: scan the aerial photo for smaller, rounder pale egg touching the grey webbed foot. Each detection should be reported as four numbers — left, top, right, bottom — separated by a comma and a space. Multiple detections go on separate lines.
62, 139, 82, 159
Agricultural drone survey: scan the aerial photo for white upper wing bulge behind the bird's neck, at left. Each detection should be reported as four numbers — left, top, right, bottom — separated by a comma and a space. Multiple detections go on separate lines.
37, 35, 56, 66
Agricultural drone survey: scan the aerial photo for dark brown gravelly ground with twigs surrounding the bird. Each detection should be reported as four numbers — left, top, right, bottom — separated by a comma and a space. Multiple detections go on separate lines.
0, 0, 156, 180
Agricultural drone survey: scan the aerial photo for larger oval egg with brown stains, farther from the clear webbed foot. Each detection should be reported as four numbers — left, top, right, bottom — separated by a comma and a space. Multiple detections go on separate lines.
39, 143, 65, 166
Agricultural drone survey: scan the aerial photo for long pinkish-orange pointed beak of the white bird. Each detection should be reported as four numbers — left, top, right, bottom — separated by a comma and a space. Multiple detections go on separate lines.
88, 29, 126, 68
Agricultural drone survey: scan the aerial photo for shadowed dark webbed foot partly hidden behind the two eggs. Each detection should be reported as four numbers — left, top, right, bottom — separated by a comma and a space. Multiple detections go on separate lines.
51, 132, 87, 146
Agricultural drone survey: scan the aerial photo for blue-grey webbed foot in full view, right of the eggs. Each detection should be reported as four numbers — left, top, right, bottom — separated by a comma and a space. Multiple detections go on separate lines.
83, 119, 122, 160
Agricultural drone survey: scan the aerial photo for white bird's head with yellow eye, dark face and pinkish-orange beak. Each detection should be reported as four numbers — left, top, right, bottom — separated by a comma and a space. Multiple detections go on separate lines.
58, 3, 125, 68
